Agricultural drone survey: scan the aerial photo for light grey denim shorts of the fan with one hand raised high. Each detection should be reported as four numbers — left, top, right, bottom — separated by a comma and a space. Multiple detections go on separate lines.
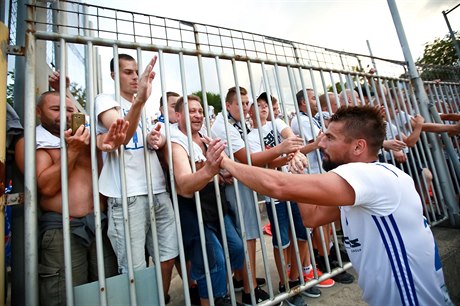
107, 192, 179, 273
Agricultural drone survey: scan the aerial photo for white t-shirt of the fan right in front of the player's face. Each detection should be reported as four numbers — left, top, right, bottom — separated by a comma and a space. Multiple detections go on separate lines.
291, 113, 321, 174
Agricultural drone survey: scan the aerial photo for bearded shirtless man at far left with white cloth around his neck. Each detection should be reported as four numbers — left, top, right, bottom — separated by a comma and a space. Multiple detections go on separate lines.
15, 91, 121, 305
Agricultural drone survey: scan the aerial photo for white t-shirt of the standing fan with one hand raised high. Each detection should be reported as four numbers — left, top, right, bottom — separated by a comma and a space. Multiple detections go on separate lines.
95, 94, 166, 198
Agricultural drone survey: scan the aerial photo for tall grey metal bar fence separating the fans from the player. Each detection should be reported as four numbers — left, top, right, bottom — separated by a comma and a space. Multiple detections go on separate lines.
8, 1, 460, 305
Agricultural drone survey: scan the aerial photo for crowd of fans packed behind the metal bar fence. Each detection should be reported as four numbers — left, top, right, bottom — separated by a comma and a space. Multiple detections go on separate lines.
9, 54, 460, 305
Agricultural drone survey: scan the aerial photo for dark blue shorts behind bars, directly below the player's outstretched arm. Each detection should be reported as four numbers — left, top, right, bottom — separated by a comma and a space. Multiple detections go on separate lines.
265, 201, 307, 249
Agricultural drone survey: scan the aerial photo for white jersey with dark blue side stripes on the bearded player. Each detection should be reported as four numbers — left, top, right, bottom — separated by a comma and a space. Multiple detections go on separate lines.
332, 162, 451, 305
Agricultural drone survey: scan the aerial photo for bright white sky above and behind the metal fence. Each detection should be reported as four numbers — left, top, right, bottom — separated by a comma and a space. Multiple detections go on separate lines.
71, 0, 460, 116
